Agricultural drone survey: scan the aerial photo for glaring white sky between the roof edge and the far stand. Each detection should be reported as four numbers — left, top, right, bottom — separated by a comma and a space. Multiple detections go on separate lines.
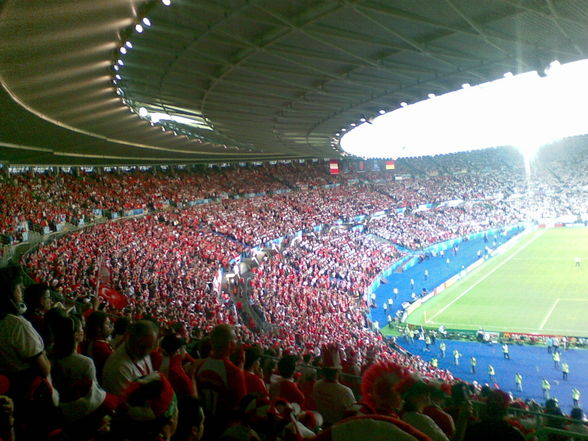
341, 60, 588, 158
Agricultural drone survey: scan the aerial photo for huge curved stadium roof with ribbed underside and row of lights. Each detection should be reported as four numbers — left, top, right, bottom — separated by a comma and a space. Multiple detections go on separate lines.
0, 0, 588, 165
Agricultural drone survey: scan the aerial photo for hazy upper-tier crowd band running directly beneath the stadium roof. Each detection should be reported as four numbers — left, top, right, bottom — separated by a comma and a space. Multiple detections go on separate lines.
0, 143, 588, 243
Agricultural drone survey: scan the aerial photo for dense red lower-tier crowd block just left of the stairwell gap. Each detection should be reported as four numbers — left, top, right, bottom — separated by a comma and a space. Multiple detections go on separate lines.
24, 214, 243, 328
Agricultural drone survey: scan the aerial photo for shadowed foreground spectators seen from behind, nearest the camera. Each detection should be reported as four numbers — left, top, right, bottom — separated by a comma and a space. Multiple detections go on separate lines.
0, 267, 587, 441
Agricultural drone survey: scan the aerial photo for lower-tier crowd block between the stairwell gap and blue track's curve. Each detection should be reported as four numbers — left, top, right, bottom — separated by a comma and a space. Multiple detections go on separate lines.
248, 231, 400, 355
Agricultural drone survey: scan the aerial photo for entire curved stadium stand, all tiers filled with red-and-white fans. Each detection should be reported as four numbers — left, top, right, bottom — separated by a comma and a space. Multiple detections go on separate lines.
0, 147, 587, 440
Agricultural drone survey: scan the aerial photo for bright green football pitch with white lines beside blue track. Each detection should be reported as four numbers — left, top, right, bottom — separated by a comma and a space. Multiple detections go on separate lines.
407, 228, 588, 337
